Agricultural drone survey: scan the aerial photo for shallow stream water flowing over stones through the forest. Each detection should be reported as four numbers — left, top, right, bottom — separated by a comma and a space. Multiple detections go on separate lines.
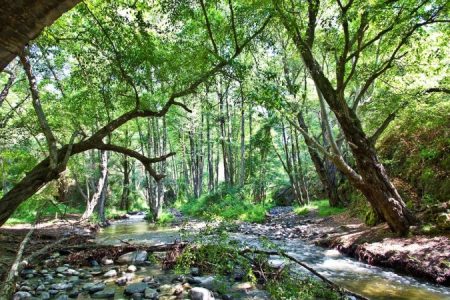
97, 217, 450, 300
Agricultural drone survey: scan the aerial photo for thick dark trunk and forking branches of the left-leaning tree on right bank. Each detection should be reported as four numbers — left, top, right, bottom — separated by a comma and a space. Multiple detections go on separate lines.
273, 0, 445, 235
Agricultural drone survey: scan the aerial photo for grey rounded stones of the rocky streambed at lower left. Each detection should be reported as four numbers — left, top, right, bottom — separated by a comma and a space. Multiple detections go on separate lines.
14, 250, 269, 300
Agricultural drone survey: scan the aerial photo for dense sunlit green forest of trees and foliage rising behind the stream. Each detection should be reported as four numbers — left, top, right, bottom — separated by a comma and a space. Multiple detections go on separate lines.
0, 0, 450, 299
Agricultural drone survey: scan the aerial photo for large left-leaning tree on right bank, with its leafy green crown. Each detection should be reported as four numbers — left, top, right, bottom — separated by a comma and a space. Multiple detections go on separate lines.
272, 0, 448, 235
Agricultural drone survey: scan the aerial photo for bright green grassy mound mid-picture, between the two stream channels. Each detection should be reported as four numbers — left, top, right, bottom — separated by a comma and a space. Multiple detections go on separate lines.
175, 188, 273, 223
